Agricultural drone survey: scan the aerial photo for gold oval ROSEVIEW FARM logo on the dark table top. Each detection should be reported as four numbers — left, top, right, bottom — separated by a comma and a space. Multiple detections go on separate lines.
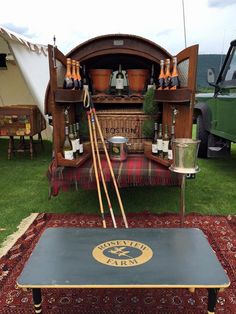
92, 240, 153, 267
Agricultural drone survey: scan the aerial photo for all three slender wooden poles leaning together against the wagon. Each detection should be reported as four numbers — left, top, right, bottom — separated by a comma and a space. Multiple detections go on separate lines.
83, 89, 128, 228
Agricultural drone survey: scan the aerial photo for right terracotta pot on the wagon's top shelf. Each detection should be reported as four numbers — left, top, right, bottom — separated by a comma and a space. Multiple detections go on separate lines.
127, 69, 149, 94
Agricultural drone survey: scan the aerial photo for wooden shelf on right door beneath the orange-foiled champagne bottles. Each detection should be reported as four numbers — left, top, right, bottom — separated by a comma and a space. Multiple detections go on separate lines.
155, 88, 192, 103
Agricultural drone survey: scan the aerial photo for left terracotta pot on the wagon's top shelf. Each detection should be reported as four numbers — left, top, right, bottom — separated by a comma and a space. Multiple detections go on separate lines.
90, 69, 112, 93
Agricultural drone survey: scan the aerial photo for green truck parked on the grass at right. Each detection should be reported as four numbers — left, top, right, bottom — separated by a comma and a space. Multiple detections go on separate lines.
194, 40, 236, 158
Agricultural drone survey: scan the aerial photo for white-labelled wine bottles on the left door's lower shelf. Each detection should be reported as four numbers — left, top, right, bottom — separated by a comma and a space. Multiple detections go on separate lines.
63, 122, 84, 160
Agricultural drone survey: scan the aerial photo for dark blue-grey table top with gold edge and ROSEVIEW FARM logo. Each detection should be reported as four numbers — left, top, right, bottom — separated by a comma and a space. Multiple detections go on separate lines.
17, 228, 230, 288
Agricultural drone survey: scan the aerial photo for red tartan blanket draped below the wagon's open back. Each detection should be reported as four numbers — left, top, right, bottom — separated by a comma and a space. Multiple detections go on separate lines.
48, 155, 180, 196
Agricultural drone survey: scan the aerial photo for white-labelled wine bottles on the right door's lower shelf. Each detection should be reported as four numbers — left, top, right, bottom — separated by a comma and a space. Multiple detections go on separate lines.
152, 122, 175, 160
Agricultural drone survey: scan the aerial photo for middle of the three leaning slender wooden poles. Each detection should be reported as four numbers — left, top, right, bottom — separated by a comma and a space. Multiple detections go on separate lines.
90, 110, 117, 228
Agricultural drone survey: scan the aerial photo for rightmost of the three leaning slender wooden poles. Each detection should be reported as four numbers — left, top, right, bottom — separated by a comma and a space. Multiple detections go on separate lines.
92, 108, 129, 228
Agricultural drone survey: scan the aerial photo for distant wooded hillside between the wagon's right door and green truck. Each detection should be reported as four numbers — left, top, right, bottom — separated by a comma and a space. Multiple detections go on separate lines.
197, 54, 225, 89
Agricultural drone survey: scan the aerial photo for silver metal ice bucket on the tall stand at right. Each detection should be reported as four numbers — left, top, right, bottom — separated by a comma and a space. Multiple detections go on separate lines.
170, 138, 201, 173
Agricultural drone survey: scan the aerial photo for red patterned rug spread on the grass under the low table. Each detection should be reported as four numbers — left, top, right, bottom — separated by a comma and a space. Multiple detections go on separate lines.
0, 213, 236, 314
